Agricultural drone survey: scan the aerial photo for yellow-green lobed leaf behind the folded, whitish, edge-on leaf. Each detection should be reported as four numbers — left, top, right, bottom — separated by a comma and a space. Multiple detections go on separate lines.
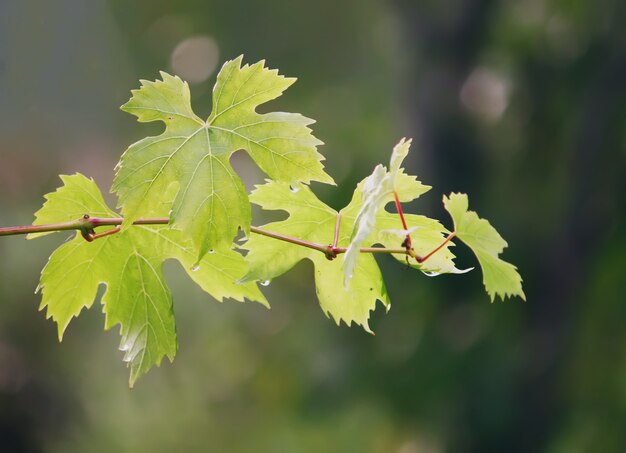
242, 175, 454, 332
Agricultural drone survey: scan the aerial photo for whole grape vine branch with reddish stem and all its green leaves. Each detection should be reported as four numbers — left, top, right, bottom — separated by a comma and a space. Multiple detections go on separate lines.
0, 56, 525, 386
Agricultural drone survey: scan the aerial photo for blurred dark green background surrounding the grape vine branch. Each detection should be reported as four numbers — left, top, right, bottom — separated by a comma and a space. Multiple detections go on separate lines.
0, 0, 626, 453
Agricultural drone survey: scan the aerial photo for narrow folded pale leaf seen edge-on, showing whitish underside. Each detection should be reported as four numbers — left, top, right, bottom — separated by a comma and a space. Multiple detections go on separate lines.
343, 138, 430, 289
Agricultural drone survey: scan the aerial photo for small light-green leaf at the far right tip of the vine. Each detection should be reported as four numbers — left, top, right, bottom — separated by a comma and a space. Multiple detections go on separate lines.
443, 193, 526, 302
